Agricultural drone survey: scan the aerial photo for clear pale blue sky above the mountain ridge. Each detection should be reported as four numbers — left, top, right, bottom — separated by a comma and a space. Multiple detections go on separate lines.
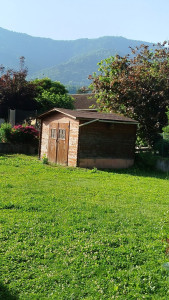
0, 0, 169, 42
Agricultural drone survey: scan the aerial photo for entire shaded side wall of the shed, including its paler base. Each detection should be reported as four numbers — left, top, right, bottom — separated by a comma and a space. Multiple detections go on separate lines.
78, 122, 137, 168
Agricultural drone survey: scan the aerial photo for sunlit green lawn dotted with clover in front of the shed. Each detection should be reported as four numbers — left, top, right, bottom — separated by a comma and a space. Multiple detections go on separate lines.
0, 155, 169, 300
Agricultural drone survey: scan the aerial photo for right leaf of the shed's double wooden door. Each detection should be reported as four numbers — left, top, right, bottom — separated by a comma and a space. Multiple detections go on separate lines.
57, 123, 69, 166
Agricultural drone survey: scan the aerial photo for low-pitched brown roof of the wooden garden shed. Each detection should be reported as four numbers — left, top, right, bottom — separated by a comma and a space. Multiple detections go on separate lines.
38, 108, 138, 124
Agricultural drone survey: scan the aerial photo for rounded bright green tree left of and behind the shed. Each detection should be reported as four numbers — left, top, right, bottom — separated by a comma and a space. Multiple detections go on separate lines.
32, 78, 74, 112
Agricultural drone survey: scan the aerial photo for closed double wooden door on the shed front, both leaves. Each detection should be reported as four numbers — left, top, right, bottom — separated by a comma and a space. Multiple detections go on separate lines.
48, 123, 69, 166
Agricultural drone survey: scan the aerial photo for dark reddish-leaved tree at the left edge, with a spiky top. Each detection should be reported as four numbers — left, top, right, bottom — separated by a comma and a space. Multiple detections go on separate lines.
0, 56, 37, 110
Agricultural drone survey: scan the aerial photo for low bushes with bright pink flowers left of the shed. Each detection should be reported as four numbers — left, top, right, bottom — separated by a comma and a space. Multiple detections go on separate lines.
0, 123, 39, 146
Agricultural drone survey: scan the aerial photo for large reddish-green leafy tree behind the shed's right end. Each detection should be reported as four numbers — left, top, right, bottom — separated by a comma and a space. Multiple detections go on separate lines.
89, 42, 169, 145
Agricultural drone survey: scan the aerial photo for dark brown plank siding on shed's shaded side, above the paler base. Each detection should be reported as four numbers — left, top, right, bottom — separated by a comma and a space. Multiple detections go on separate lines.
79, 122, 136, 159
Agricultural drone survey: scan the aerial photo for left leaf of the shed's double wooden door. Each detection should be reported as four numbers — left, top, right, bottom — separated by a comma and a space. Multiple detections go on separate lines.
48, 123, 58, 163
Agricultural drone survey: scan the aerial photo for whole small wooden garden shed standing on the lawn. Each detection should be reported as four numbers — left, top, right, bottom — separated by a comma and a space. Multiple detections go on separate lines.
39, 108, 137, 168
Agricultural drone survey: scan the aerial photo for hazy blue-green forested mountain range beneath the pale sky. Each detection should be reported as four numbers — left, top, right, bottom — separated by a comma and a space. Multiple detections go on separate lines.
0, 28, 151, 86
